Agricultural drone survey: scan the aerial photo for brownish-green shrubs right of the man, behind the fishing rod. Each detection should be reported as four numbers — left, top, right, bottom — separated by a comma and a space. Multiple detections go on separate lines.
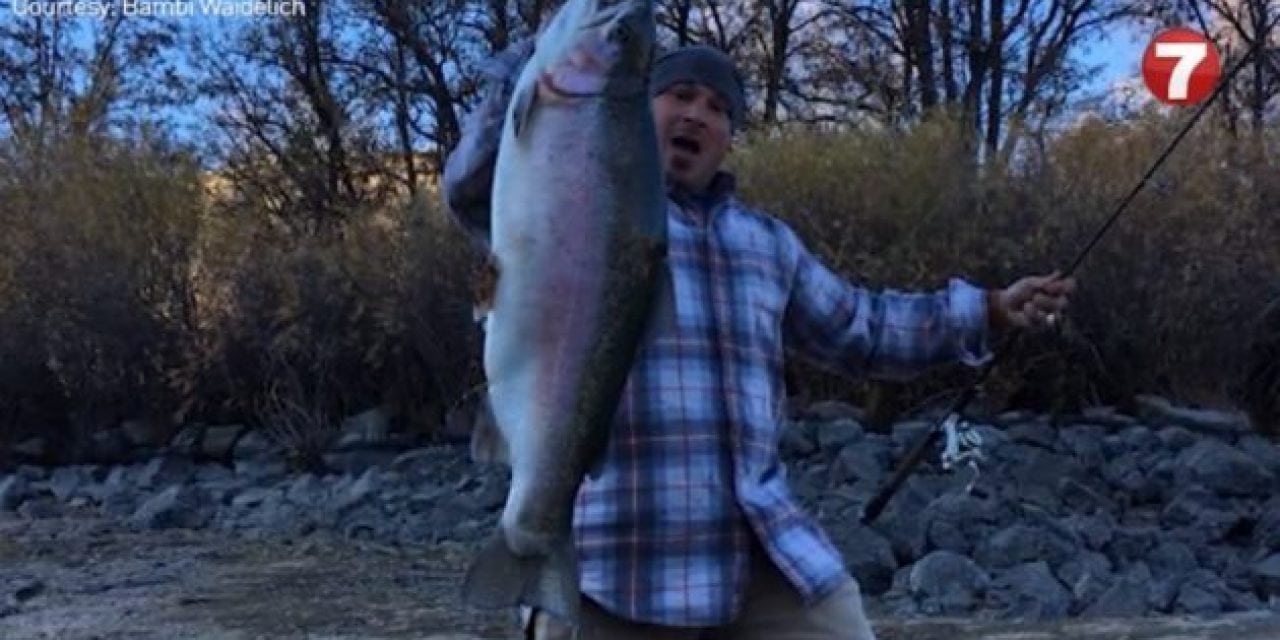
732, 113, 1280, 424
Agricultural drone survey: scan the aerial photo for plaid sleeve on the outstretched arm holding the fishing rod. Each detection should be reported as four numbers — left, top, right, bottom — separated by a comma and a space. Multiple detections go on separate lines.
783, 224, 992, 380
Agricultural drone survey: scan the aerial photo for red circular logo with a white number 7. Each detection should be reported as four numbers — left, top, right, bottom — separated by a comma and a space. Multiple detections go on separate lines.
1142, 28, 1222, 105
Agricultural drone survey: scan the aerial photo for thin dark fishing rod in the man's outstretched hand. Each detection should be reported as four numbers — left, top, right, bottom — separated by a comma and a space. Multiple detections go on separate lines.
861, 22, 1275, 525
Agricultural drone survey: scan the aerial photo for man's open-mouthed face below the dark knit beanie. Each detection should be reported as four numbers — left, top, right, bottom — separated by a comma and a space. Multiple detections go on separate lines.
653, 82, 732, 192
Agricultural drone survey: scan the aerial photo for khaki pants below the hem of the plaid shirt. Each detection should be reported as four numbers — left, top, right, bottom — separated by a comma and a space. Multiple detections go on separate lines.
522, 552, 876, 640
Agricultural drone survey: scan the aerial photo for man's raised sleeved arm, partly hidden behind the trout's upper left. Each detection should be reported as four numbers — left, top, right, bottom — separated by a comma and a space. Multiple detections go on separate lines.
443, 38, 534, 248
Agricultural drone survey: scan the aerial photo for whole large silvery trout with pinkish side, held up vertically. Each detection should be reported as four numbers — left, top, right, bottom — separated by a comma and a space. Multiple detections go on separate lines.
463, 0, 671, 625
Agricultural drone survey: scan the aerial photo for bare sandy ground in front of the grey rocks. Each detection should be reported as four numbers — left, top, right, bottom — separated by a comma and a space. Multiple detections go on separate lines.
0, 516, 1280, 640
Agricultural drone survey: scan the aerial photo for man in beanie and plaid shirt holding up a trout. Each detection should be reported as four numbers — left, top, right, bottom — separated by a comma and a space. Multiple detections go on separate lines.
445, 45, 1074, 640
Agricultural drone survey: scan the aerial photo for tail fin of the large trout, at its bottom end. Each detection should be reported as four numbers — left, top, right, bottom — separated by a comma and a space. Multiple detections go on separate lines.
462, 530, 581, 627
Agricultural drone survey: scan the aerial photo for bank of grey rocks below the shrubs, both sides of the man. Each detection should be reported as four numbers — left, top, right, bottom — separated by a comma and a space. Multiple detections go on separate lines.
0, 398, 1280, 629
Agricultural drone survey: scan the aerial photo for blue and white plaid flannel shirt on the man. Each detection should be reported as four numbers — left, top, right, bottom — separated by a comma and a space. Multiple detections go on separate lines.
573, 174, 991, 626
